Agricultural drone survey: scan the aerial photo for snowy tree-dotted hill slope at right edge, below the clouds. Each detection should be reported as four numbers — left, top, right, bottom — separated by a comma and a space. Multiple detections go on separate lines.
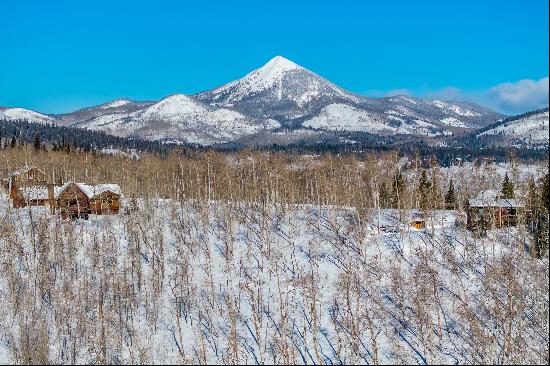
477, 108, 549, 146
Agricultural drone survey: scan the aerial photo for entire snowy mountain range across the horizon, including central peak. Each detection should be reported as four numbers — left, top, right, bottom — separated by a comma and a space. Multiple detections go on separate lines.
0, 56, 548, 145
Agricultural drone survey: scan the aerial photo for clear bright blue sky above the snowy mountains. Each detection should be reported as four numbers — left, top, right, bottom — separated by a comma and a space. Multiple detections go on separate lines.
0, 0, 549, 113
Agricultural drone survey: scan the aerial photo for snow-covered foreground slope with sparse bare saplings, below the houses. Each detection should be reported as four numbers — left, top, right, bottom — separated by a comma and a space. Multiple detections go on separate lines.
0, 199, 549, 364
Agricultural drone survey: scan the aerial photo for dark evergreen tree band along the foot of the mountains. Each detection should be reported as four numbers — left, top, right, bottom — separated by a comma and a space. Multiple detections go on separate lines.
0, 120, 548, 166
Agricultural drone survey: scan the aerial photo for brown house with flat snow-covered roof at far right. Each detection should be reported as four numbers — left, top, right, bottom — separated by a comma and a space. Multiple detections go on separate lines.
466, 199, 524, 231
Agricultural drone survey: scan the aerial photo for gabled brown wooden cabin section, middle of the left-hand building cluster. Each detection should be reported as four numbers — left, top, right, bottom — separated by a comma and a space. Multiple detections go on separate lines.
52, 182, 93, 220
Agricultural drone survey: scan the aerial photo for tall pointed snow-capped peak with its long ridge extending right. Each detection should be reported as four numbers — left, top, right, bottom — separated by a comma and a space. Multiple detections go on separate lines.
197, 56, 501, 134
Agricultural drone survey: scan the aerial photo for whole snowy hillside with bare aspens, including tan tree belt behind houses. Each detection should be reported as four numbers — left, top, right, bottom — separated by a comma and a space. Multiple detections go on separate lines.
0, 145, 549, 364
